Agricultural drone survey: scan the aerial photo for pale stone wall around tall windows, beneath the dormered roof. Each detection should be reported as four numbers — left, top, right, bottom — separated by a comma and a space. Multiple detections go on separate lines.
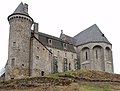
48, 47, 77, 72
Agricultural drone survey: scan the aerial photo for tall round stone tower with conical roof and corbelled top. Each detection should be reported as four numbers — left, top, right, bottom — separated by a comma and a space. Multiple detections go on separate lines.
5, 3, 33, 79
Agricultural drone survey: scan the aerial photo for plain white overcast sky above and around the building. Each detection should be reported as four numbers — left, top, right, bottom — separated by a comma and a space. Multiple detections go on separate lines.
0, 0, 120, 73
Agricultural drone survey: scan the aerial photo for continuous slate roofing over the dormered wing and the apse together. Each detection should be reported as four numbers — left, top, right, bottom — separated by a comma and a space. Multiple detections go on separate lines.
39, 24, 111, 52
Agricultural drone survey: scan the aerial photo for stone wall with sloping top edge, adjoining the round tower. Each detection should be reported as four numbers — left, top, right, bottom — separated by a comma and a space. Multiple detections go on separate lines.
30, 38, 51, 77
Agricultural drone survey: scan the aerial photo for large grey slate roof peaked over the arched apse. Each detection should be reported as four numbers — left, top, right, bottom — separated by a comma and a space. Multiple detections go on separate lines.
74, 24, 111, 45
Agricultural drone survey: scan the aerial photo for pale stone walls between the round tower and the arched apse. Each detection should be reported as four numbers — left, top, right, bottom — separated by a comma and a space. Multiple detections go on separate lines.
31, 34, 77, 77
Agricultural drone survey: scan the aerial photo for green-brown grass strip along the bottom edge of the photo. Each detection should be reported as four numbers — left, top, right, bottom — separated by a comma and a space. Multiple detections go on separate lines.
0, 83, 113, 91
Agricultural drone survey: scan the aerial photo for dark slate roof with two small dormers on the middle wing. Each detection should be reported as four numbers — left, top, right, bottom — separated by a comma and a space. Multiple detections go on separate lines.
39, 32, 75, 52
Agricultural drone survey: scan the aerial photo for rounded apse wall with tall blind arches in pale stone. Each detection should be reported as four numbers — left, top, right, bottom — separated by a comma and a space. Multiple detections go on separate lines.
77, 43, 113, 72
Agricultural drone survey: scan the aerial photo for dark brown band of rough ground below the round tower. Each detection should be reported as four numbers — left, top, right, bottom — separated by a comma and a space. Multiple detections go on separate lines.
0, 77, 71, 89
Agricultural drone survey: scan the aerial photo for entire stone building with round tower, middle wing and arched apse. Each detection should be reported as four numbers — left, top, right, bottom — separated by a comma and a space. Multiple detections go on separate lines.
5, 3, 113, 80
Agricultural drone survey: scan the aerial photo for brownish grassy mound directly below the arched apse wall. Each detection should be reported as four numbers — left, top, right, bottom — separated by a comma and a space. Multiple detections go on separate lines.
48, 69, 120, 82
